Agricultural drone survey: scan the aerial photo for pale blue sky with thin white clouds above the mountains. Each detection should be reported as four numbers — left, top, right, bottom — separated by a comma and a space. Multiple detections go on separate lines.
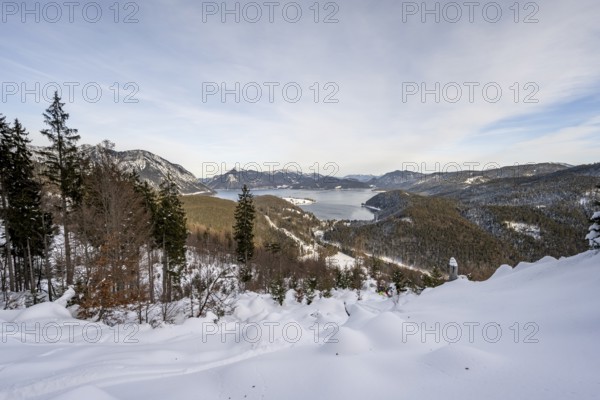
0, 0, 600, 177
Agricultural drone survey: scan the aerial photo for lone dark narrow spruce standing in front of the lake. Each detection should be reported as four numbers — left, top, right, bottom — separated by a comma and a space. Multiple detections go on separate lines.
233, 185, 256, 284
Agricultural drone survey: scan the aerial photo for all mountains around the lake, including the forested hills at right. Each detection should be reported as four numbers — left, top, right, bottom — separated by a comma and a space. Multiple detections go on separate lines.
33, 146, 600, 278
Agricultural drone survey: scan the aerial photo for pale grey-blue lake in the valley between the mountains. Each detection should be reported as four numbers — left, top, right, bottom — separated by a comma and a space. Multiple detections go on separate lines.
215, 189, 377, 221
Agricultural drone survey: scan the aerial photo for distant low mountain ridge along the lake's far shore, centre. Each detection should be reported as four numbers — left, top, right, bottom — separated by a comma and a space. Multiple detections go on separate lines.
203, 169, 369, 190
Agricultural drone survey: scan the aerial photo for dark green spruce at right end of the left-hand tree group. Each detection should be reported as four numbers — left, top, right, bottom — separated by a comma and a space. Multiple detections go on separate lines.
154, 178, 187, 301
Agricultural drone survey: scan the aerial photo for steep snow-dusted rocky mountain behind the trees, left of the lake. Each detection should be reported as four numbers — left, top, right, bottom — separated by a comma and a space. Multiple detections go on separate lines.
31, 145, 214, 194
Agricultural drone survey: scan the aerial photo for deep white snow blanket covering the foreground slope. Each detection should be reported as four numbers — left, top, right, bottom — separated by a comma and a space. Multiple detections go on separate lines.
0, 251, 600, 400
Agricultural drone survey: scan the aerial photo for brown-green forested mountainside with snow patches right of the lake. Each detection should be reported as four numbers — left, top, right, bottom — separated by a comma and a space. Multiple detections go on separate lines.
324, 163, 600, 278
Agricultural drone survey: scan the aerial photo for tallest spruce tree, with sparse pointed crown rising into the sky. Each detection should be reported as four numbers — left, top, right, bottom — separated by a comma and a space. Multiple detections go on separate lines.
41, 92, 82, 285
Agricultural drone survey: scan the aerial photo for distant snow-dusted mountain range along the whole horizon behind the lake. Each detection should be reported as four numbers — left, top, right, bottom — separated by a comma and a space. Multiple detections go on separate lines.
31, 145, 600, 205
